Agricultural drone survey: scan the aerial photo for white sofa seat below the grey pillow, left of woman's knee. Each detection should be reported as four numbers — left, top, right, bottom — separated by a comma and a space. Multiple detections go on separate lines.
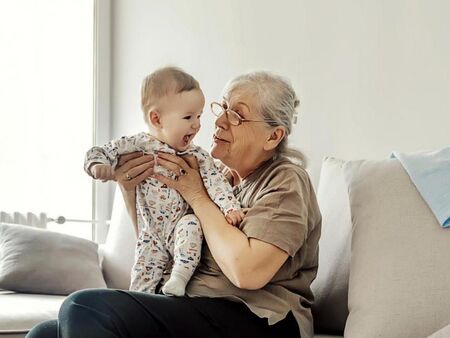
0, 291, 65, 334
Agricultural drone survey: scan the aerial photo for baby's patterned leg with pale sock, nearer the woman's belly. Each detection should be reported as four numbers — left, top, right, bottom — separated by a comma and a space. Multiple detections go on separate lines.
162, 215, 203, 296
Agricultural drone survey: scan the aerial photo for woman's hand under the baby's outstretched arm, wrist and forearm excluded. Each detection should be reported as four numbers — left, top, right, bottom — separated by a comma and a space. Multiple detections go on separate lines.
114, 152, 155, 192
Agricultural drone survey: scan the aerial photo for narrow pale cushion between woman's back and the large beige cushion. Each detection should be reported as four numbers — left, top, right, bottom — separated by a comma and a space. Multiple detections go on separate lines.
311, 157, 352, 335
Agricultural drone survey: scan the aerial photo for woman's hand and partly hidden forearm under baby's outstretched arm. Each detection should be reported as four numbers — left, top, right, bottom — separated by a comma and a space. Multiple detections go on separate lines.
114, 152, 154, 236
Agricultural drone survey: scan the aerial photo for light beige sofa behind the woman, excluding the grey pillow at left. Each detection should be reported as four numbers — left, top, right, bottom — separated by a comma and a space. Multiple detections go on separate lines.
0, 157, 450, 338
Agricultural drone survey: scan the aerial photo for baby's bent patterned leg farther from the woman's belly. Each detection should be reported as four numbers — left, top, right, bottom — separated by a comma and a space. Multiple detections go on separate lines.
130, 231, 169, 293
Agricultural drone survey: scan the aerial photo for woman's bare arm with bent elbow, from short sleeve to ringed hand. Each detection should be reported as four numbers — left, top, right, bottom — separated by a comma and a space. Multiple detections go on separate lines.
154, 154, 288, 289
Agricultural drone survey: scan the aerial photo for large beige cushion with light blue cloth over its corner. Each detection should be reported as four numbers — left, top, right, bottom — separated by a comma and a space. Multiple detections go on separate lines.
344, 159, 450, 338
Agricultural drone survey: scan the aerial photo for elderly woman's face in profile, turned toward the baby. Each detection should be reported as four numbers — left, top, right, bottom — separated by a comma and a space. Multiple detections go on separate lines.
211, 92, 270, 172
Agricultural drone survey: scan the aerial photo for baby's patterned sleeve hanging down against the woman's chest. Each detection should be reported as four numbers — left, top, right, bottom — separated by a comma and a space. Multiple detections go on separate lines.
197, 151, 241, 215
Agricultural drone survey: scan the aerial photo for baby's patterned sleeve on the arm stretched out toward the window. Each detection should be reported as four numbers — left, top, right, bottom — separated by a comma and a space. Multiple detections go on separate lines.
84, 133, 148, 176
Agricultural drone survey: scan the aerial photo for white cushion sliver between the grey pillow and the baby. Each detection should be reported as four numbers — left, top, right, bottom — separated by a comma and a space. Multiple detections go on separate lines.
101, 190, 136, 290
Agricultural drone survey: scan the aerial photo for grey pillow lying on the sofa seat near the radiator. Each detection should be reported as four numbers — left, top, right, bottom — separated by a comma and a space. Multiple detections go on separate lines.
0, 223, 106, 295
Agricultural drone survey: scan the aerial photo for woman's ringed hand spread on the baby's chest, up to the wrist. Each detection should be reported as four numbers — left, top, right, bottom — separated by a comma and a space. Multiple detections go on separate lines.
153, 153, 209, 207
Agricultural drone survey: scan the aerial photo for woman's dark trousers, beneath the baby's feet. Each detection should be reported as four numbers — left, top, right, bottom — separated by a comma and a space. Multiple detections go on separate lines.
26, 289, 300, 338
